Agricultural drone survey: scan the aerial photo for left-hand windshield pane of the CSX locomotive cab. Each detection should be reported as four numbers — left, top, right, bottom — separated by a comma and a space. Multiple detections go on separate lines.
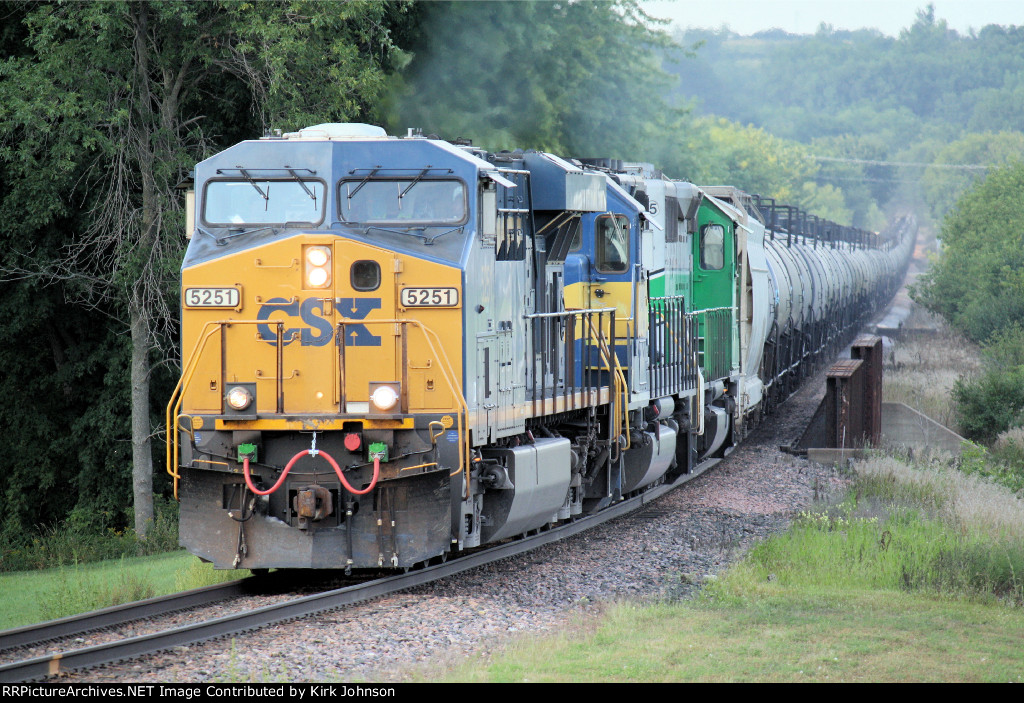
203, 179, 326, 227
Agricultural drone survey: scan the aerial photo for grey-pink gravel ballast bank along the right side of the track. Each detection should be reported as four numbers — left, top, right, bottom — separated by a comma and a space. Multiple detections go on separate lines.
61, 372, 844, 684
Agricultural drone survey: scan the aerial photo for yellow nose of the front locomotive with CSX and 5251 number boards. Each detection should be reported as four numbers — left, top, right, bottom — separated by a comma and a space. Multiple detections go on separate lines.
182, 235, 462, 429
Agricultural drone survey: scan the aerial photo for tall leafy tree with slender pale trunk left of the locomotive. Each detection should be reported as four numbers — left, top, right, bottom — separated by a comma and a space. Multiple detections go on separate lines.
0, 1, 404, 535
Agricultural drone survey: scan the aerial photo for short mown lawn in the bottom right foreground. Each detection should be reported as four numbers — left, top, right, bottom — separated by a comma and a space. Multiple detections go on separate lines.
440, 597, 1024, 683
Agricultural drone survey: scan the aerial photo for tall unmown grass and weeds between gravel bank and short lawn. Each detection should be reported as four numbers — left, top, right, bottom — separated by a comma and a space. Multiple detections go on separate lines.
708, 454, 1024, 605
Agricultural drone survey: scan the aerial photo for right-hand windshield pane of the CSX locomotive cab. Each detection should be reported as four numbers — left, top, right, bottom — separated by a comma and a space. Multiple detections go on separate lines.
338, 178, 466, 227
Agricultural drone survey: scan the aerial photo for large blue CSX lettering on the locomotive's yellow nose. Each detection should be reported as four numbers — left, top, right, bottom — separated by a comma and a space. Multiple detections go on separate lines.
256, 298, 381, 347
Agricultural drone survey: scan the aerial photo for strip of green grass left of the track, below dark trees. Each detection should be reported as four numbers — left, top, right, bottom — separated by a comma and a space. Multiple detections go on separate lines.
0, 552, 249, 629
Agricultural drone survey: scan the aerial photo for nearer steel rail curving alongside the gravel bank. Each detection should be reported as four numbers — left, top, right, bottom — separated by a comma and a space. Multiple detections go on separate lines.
0, 459, 720, 684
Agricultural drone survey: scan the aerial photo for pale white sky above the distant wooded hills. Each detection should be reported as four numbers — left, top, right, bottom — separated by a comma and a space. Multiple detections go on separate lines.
641, 0, 1024, 37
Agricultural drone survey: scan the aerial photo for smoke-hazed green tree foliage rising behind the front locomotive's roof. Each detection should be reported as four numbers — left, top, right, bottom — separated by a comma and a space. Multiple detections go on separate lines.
388, 0, 679, 159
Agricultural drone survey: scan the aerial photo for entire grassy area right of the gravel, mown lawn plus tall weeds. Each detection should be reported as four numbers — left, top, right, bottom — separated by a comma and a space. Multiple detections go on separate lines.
413, 456, 1024, 683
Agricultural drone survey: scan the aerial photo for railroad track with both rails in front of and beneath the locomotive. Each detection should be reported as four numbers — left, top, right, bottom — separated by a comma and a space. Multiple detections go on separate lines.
0, 459, 719, 684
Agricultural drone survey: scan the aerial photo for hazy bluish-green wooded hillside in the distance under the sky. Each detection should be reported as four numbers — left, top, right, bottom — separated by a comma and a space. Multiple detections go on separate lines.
668, 6, 1024, 228
